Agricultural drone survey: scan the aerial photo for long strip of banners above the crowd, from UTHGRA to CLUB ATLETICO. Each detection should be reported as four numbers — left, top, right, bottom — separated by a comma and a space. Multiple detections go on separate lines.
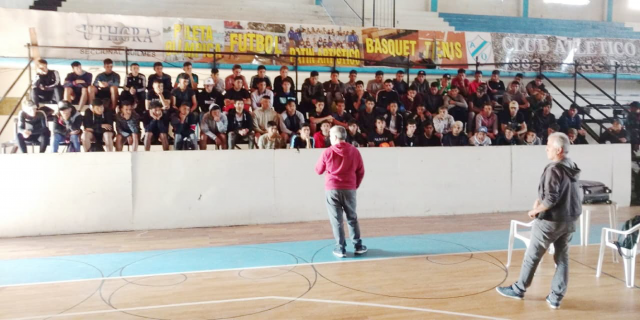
0, 9, 640, 73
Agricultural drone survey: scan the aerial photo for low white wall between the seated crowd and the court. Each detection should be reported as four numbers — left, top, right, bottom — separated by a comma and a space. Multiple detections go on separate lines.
0, 145, 631, 237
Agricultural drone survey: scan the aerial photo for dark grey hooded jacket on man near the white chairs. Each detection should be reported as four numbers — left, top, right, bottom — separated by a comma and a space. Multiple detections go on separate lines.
538, 158, 582, 222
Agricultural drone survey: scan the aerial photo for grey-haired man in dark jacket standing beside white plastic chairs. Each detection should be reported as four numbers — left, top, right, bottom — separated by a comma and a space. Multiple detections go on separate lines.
496, 132, 582, 309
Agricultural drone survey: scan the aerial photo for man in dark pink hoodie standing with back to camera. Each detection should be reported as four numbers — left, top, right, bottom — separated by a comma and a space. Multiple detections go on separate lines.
316, 126, 367, 258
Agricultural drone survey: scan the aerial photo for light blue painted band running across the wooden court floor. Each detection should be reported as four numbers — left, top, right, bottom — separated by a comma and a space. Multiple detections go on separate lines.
0, 225, 604, 286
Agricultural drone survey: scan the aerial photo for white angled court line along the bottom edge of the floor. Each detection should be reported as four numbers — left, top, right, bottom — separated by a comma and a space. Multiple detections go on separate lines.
5, 296, 504, 320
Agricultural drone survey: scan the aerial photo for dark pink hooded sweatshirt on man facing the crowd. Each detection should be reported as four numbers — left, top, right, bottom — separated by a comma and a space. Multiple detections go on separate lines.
316, 142, 364, 190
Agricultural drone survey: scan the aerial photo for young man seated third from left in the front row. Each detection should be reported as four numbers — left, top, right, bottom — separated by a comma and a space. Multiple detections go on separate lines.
82, 99, 115, 152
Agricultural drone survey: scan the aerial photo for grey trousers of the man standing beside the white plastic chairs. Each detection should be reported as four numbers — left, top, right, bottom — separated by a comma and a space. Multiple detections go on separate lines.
512, 220, 576, 302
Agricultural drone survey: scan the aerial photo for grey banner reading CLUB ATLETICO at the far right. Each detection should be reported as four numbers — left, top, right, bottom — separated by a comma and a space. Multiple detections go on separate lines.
491, 33, 640, 73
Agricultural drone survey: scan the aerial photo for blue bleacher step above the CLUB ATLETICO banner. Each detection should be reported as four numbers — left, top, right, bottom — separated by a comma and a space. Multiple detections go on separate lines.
440, 13, 640, 39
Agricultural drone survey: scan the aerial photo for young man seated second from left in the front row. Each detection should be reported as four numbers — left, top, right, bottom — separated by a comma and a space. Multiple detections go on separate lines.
53, 100, 82, 153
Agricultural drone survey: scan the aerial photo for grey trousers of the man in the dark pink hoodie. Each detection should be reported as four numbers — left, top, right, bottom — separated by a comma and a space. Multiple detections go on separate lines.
325, 190, 362, 249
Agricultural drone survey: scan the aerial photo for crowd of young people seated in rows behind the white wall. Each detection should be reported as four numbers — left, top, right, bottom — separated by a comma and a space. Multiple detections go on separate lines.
17, 59, 640, 152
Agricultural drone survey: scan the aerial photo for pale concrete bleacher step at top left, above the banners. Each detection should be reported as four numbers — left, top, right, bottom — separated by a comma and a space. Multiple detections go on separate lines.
58, 0, 332, 25
